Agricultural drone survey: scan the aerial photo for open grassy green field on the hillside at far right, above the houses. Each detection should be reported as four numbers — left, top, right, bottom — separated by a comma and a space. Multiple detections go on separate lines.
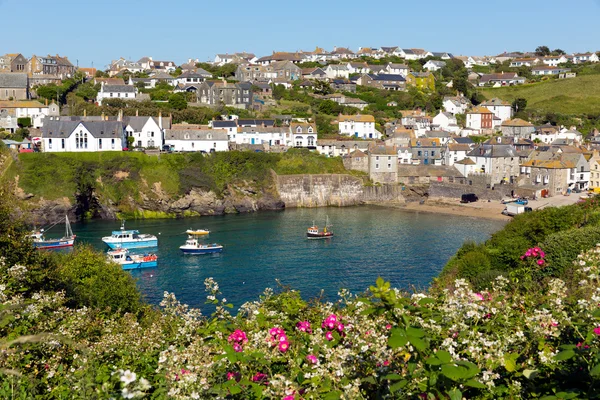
481, 75, 600, 114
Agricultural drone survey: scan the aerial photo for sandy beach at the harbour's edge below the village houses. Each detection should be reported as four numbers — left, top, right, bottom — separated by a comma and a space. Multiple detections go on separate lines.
372, 195, 579, 222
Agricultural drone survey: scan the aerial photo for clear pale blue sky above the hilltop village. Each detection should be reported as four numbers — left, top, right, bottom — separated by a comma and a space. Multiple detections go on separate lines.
0, 0, 600, 68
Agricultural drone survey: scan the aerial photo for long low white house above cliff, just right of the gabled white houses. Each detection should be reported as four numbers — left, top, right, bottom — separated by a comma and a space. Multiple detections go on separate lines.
165, 129, 229, 153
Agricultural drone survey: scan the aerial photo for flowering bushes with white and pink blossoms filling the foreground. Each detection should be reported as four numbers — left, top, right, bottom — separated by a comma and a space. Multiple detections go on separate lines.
0, 247, 600, 400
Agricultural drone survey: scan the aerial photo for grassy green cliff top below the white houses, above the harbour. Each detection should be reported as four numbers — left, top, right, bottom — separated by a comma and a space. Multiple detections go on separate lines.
1, 150, 360, 203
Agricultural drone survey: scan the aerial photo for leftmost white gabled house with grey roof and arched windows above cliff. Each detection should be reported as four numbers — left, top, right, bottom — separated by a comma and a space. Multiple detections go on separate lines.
42, 117, 125, 153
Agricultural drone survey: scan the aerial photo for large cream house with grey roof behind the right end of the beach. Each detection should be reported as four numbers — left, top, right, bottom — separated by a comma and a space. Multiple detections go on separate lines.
464, 144, 519, 187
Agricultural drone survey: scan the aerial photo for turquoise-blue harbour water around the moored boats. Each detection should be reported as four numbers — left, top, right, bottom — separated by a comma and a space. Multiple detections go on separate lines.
68, 206, 504, 307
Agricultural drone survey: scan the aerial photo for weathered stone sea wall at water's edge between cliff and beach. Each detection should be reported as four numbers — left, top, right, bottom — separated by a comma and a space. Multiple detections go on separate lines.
276, 174, 404, 207
